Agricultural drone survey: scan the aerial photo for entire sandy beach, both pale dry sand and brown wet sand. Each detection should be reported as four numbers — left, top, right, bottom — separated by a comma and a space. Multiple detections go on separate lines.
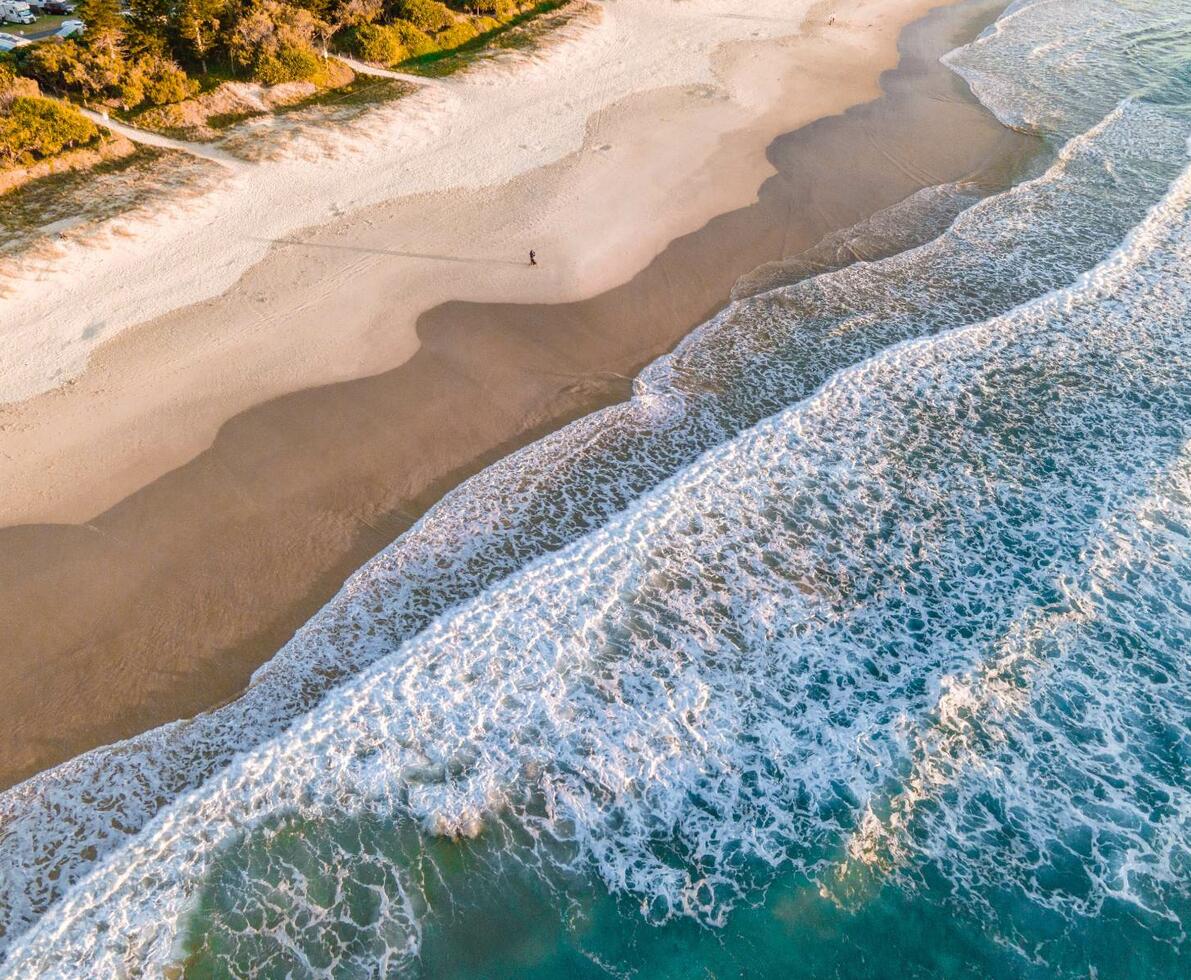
0, 0, 1034, 786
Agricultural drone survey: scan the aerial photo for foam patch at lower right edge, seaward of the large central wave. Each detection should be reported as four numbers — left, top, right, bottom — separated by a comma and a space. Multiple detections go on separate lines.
834, 445, 1191, 943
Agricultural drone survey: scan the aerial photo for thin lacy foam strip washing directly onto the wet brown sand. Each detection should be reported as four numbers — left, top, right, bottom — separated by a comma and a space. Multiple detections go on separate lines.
0, 70, 1184, 971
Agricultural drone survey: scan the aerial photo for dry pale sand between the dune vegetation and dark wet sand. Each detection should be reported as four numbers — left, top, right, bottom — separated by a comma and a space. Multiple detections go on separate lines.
0, 0, 930, 524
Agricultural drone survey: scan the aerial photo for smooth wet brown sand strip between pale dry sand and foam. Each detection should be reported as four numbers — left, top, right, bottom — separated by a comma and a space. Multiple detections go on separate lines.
0, 4, 1033, 786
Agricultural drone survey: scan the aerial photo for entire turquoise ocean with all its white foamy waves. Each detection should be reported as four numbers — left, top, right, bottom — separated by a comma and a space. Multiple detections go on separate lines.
0, 0, 1191, 978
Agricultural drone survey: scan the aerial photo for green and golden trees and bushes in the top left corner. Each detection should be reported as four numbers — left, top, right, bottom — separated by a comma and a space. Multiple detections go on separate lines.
0, 0, 561, 168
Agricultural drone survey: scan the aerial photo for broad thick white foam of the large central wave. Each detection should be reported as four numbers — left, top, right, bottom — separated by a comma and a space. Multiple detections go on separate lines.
6, 128, 1191, 975
